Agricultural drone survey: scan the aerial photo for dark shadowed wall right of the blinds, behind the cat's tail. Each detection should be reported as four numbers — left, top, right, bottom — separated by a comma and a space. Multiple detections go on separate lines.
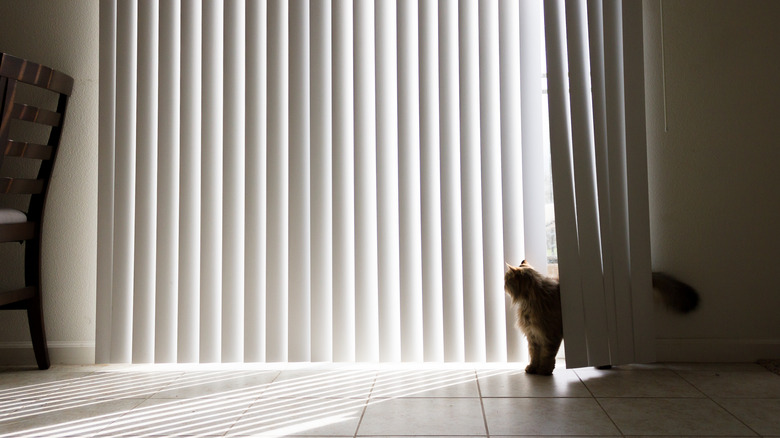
645, 0, 780, 361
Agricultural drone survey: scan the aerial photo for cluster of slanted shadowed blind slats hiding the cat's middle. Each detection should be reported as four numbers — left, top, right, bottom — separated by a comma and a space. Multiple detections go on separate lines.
545, 0, 654, 367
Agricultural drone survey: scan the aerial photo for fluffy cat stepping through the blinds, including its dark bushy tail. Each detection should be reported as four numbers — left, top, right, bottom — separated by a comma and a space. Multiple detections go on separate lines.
504, 260, 699, 375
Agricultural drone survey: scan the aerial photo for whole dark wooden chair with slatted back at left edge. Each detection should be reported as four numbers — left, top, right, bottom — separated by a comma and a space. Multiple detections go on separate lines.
0, 52, 73, 370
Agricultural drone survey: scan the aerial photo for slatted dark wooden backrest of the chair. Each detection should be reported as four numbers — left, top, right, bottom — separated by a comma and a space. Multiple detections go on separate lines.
0, 52, 73, 241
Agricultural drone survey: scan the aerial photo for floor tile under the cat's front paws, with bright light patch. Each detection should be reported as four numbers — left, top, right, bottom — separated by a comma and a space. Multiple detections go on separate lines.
478, 369, 591, 397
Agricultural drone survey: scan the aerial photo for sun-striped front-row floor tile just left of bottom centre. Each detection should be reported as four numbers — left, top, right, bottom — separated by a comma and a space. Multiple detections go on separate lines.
227, 398, 367, 436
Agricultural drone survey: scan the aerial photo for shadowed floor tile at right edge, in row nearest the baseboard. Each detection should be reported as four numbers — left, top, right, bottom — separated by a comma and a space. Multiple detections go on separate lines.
678, 371, 780, 398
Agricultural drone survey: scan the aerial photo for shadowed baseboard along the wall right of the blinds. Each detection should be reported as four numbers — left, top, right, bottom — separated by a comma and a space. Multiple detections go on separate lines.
656, 339, 780, 362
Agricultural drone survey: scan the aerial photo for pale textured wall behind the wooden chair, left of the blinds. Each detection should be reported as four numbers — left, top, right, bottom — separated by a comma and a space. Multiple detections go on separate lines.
0, 0, 98, 364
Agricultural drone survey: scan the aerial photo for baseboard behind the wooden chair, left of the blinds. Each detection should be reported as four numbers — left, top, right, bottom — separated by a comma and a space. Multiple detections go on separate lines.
0, 341, 95, 366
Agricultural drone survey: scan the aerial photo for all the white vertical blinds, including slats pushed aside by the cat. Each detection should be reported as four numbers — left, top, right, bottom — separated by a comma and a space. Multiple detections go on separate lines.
96, 0, 652, 364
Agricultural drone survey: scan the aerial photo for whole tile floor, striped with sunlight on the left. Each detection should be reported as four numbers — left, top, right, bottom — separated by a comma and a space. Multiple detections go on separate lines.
0, 364, 780, 437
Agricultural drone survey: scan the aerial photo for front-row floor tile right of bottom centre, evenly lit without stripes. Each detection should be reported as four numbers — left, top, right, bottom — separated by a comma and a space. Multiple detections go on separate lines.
358, 398, 486, 436
